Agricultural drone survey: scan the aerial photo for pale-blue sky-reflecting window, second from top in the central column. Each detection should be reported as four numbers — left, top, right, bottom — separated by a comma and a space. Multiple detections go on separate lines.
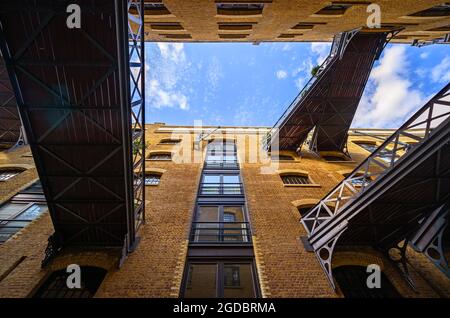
200, 173, 243, 195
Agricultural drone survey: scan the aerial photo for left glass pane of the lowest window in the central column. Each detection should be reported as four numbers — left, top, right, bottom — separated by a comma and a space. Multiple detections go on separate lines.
184, 264, 217, 298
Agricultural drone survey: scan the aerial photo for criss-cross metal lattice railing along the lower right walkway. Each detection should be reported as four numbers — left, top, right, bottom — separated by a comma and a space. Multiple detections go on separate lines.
301, 84, 450, 237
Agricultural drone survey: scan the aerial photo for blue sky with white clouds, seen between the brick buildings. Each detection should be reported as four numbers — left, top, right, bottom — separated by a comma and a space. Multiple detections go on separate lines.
146, 43, 450, 128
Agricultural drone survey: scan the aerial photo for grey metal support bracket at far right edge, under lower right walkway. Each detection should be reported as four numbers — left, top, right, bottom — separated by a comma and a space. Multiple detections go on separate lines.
410, 205, 450, 278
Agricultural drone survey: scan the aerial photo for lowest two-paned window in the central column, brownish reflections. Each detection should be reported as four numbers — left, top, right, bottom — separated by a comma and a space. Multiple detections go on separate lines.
183, 260, 257, 298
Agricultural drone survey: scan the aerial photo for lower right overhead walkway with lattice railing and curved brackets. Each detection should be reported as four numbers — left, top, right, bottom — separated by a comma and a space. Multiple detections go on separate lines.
301, 84, 450, 287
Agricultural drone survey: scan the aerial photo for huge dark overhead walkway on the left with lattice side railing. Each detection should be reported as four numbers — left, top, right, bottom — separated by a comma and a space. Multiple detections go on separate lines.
0, 0, 145, 265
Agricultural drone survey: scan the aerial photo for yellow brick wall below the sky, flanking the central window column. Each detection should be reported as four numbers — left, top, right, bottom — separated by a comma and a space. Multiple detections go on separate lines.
0, 125, 450, 297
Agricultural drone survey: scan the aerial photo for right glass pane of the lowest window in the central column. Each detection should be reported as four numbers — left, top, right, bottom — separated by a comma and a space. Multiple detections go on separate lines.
223, 264, 256, 298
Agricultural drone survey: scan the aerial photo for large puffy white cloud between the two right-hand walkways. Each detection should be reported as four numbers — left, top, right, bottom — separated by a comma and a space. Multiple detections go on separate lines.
352, 46, 425, 128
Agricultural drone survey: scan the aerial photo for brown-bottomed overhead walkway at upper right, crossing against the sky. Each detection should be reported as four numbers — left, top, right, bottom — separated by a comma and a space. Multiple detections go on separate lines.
264, 29, 394, 153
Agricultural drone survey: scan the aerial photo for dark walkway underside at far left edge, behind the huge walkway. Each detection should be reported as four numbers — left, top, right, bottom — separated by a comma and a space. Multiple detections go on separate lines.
0, 53, 21, 148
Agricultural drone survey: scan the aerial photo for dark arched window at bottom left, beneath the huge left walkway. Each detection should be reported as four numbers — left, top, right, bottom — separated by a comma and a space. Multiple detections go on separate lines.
33, 266, 107, 298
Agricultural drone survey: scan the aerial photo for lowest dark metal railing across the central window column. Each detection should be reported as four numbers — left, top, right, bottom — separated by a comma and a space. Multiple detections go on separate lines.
189, 222, 252, 244
